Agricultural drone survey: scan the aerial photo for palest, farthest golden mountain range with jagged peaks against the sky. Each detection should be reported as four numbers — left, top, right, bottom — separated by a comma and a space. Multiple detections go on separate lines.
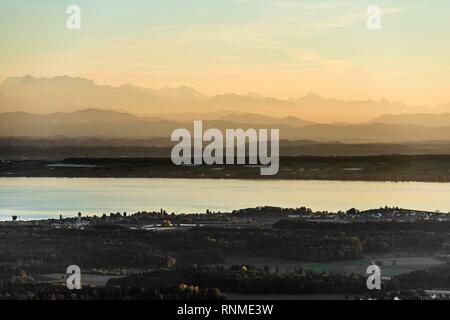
0, 76, 450, 125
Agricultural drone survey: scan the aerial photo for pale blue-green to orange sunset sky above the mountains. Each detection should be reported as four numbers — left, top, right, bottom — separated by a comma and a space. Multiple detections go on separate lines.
0, 0, 450, 106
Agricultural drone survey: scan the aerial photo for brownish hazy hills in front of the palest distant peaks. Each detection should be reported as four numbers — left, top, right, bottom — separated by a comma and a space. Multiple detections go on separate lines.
0, 109, 450, 143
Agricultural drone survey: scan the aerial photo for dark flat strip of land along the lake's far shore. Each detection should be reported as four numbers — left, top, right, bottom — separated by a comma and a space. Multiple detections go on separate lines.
4, 155, 450, 183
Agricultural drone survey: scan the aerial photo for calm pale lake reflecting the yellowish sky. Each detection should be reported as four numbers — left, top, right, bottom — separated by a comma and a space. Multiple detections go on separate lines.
0, 178, 450, 220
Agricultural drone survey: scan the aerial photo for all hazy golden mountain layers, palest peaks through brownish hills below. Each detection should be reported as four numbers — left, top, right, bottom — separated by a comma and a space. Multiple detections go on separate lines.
0, 76, 450, 143
